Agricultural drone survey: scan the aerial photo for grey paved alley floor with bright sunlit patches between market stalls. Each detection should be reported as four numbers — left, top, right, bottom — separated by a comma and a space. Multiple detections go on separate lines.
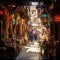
16, 41, 47, 60
